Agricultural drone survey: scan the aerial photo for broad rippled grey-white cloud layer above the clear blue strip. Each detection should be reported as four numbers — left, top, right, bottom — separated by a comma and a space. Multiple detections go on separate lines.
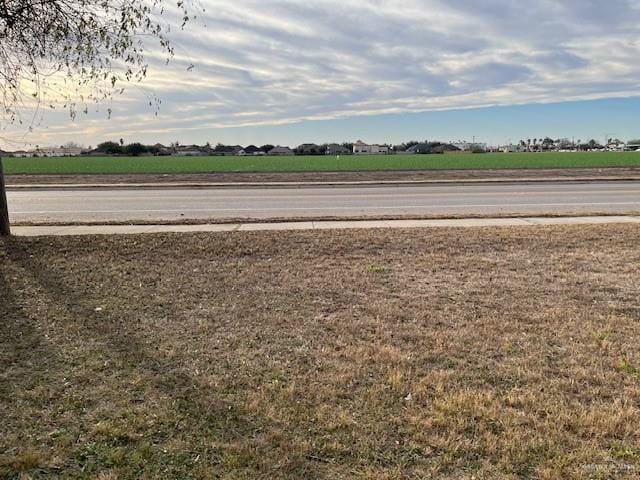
3, 0, 640, 143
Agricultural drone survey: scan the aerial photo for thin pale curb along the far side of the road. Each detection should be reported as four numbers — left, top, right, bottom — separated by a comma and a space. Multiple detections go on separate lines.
6, 177, 640, 190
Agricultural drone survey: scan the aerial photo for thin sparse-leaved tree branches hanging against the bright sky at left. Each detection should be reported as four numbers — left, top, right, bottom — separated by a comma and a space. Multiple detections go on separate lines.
0, 0, 195, 125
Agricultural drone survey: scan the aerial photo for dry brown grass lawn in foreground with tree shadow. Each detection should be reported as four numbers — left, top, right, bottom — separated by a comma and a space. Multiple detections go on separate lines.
0, 225, 640, 480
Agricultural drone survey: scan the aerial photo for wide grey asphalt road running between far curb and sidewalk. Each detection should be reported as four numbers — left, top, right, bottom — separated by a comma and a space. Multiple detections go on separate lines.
8, 181, 640, 222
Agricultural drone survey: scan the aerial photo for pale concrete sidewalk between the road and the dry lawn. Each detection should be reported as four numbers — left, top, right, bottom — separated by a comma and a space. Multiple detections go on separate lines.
12, 216, 640, 237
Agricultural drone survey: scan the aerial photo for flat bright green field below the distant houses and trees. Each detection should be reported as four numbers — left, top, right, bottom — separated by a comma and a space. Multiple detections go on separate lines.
3, 152, 640, 175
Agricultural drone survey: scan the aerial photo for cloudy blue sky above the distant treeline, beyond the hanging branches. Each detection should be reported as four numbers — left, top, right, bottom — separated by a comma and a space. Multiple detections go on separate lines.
0, 0, 640, 148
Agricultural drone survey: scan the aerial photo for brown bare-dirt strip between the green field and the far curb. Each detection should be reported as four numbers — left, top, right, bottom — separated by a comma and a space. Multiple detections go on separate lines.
6, 168, 640, 186
